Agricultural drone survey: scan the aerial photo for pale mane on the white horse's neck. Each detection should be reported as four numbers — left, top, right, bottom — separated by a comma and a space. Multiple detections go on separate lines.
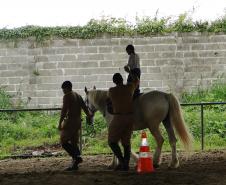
89, 90, 108, 109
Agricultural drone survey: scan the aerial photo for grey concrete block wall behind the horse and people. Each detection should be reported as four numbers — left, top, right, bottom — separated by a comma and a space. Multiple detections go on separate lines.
0, 33, 226, 107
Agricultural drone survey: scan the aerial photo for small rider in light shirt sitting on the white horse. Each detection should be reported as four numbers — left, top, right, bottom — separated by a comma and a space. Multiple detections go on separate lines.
124, 44, 141, 99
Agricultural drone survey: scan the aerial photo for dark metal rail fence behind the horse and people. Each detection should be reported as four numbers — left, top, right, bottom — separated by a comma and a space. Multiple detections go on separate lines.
0, 102, 226, 151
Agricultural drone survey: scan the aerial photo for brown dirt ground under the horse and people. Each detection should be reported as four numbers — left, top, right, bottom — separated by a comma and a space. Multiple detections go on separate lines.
0, 150, 226, 185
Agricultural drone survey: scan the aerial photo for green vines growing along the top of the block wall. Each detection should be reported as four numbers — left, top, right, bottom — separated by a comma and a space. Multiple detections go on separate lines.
0, 14, 226, 41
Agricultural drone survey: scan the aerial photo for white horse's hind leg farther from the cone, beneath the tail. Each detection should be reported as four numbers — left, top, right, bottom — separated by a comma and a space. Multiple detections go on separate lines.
163, 115, 179, 168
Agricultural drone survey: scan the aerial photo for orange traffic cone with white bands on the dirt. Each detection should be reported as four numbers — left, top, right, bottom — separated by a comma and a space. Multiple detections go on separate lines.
137, 131, 154, 173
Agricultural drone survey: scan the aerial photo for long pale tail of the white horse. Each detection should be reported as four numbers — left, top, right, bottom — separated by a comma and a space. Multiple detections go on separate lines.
168, 94, 193, 152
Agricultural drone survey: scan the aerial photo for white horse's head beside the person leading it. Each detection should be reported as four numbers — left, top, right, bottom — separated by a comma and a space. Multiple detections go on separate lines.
85, 86, 97, 125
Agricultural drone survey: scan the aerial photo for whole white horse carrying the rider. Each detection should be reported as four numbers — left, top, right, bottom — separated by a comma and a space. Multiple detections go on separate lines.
85, 87, 192, 168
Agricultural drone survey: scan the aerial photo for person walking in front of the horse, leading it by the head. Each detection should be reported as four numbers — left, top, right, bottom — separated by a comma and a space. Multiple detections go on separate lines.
58, 81, 91, 171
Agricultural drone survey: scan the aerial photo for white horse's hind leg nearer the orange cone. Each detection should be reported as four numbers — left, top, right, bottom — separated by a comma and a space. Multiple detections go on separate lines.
149, 123, 164, 168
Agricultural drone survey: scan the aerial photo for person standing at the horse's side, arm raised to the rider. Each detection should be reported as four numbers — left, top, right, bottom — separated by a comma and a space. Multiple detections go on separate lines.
108, 73, 139, 171
